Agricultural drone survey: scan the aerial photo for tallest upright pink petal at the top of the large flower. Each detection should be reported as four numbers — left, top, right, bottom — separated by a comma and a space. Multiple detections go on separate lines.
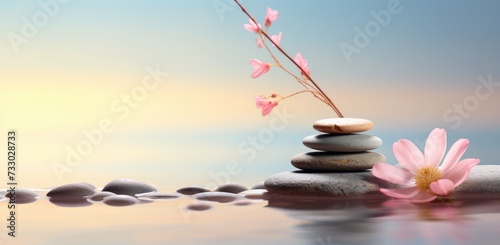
424, 128, 446, 167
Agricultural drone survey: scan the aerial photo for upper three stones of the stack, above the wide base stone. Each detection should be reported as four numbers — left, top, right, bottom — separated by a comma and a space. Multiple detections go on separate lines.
292, 118, 386, 172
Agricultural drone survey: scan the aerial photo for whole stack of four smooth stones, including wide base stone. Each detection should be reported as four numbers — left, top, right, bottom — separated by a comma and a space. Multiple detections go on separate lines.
264, 118, 390, 196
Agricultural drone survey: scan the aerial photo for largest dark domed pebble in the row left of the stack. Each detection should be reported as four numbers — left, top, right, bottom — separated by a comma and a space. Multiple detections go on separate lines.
102, 179, 157, 196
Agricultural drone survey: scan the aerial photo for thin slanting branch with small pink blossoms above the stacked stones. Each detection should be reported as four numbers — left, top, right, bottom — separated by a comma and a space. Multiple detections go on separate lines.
234, 0, 344, 117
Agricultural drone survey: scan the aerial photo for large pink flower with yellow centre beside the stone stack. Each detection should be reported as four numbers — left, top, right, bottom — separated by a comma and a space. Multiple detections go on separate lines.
372, 128, 479, 203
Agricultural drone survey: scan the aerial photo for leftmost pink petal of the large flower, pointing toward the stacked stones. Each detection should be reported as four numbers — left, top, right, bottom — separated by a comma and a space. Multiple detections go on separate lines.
372, 163, 414, 185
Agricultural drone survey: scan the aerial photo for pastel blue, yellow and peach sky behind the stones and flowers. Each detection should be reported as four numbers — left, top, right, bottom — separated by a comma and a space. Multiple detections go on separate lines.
0, 0, 500, 190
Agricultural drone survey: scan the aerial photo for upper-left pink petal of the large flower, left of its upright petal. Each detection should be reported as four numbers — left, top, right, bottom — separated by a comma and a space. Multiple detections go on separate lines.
392, 139, 425, 172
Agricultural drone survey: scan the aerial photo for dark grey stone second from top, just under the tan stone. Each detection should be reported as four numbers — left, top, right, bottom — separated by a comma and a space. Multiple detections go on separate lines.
302, 134, 382, 152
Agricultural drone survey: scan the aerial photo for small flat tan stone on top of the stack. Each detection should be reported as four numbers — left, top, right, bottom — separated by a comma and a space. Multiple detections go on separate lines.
313, 118, 373, 134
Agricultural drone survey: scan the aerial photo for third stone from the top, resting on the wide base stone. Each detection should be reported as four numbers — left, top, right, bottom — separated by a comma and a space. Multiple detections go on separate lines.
291, 151, 386, 171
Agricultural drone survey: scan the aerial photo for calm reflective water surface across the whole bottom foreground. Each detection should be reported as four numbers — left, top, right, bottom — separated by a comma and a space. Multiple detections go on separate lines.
0, 193, 500, 245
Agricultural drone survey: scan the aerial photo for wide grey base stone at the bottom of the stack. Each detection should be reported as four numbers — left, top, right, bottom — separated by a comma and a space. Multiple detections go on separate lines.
264, 170, 397, 196
